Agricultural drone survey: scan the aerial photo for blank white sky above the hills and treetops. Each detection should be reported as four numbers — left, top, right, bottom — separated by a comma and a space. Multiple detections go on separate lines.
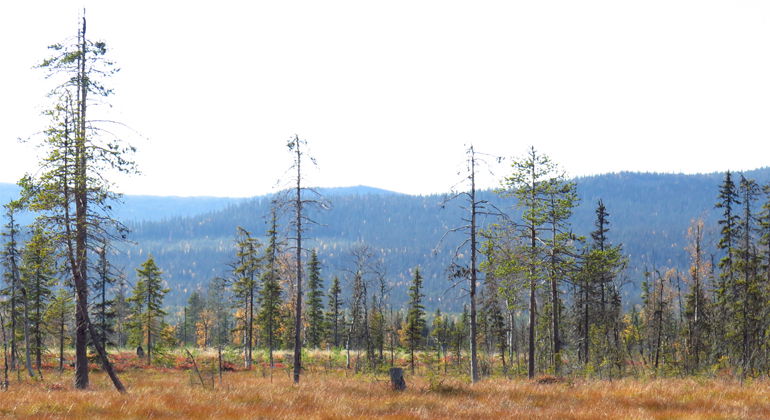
0, 0, 770, 196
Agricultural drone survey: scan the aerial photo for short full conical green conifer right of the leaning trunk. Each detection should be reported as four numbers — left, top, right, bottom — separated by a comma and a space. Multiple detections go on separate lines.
128, 255, 169, 365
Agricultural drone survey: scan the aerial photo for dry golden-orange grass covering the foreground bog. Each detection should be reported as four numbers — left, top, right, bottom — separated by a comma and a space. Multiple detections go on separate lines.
0, 352, 770, 419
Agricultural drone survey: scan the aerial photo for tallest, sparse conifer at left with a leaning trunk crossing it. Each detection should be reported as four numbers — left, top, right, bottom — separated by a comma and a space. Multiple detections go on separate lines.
19, 16, 135, 392
